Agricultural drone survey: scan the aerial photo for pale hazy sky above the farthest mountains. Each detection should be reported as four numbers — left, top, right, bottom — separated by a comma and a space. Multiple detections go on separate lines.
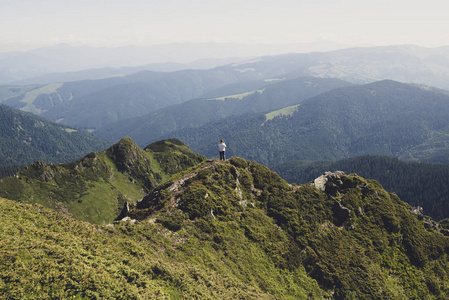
0, 0, 449, 52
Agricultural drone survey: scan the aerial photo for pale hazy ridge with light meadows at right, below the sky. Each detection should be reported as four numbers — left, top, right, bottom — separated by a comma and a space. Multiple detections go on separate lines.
218, 45, 449, 89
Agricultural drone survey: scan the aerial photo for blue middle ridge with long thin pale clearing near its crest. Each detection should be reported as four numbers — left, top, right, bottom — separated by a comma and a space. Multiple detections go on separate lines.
96, 77, 350, 145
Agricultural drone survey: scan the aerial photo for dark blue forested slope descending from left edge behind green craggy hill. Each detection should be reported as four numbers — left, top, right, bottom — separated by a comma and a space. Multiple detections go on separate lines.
0, 104, 110, 169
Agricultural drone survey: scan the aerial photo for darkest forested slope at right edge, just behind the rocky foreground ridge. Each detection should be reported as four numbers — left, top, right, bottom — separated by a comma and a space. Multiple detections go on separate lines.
272, 155, 449, 220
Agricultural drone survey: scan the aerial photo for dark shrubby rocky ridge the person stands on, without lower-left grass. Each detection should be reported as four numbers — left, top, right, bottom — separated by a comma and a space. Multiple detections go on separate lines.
124, 157, 449, 299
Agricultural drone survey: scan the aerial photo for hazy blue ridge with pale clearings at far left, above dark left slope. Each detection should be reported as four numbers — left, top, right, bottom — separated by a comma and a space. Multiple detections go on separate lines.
0, 68, 260, 130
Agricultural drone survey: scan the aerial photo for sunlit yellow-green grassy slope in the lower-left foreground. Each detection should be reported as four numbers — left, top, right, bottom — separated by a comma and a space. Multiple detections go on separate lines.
0, 198, 321, 299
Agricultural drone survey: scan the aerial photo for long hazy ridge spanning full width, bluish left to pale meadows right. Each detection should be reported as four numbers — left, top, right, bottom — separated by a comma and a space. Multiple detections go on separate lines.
0, 46, 449, 134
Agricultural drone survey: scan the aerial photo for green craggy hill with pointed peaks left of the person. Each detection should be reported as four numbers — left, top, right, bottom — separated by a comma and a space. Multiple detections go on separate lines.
0, 138, 204, 224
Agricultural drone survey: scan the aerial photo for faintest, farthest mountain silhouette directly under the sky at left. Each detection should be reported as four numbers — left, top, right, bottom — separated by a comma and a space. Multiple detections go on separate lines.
0, 43, 342, 84
